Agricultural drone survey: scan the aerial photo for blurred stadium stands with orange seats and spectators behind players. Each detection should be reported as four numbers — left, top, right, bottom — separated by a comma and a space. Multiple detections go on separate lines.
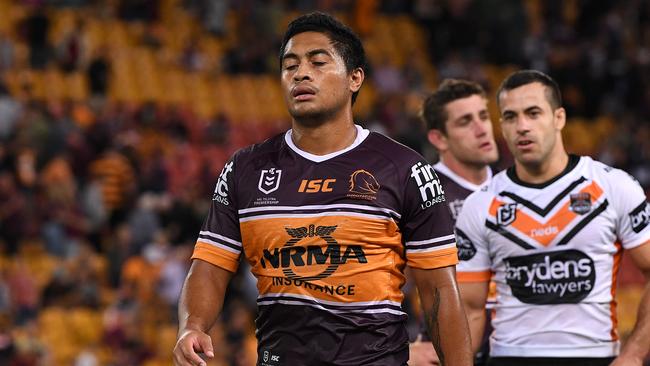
0, 0, 650, 366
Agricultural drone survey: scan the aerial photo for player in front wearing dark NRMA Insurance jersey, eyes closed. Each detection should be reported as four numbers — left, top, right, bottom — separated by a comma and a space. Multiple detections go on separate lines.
174, 13, 471, 366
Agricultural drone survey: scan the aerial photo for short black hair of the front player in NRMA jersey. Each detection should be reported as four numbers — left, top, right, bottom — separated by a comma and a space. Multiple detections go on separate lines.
280, 12, 366, 104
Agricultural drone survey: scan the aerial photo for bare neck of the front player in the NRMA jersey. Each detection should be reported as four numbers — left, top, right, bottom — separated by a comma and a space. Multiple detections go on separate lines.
291, 113, 357, 155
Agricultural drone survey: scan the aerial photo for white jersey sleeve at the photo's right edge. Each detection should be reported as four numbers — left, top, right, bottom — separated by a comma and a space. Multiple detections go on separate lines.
609, 169, 650, 249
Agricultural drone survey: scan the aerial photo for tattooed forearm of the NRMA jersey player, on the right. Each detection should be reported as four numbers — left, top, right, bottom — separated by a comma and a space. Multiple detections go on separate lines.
423, 284, 472, 366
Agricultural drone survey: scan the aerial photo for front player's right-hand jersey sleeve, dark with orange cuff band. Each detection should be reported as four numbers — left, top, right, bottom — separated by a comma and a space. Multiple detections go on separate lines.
401, 160, 458, 269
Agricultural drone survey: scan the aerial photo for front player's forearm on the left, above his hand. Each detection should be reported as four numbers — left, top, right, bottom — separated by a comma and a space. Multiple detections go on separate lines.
178, 260, 231, 332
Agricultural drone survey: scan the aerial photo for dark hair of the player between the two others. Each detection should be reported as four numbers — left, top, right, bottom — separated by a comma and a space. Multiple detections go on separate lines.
422, 79, 485, 134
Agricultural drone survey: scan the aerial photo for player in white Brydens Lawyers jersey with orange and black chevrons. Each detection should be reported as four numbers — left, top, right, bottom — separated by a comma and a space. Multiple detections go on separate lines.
456, 70, 650, 366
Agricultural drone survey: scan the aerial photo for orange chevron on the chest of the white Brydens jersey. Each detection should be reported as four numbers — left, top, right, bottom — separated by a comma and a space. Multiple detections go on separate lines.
489, 182, 603, 246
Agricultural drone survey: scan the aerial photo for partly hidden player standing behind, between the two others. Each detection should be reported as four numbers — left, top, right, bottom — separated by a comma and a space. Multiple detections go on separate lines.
409, 79, 499, 366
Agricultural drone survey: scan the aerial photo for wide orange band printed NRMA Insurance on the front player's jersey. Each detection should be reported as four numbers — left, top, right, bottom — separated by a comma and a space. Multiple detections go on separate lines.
240, 214, 426, 303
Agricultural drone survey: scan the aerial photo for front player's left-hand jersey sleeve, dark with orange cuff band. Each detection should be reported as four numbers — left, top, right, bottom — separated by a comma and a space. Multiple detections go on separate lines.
192, 158, 242, 272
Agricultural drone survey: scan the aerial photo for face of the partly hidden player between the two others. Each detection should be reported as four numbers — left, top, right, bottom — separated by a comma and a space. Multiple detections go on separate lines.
444, 95, 499, 166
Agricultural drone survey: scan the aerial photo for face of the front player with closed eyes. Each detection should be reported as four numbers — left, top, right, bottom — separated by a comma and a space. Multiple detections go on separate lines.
282, 32, 363, 122
